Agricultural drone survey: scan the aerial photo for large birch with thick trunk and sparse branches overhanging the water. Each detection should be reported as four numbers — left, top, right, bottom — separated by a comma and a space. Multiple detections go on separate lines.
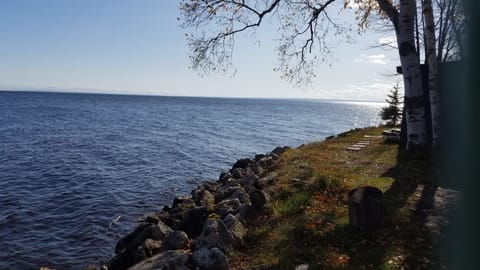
180, 0, 427, 149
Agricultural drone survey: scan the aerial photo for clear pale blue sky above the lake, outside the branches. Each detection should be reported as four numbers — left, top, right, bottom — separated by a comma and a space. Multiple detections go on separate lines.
0, 0, 399, 101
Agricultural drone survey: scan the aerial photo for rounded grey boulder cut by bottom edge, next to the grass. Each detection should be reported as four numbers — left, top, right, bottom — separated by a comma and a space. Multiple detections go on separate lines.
192, 248, 229, 270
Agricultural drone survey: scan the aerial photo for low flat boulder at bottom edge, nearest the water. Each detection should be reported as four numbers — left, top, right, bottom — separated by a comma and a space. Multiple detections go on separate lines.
126, 250, 192, 270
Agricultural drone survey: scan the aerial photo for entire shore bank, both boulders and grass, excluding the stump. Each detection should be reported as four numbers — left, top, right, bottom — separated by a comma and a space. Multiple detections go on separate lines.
82, 127, 459, 270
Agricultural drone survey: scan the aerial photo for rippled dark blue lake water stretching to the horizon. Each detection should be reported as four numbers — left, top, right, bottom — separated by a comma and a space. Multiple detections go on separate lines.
0, 92, 383, 269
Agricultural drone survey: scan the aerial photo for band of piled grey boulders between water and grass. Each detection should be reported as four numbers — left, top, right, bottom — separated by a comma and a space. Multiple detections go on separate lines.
102, 147, 289, 270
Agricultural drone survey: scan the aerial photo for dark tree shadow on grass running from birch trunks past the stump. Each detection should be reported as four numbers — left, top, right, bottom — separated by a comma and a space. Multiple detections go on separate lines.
312, 144, 439, 269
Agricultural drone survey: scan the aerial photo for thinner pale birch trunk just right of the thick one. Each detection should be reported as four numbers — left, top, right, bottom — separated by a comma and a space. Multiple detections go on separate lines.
422, 0, 440, 147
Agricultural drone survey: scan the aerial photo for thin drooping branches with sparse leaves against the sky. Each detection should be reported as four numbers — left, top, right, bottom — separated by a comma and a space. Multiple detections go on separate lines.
180, 0, 353, 84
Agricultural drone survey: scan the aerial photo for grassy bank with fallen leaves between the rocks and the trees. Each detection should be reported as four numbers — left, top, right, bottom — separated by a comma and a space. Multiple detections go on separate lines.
229, 128, 458, 269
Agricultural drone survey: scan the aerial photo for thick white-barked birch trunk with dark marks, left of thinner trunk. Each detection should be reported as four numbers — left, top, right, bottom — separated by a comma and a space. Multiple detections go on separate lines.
394, 0, 427, 150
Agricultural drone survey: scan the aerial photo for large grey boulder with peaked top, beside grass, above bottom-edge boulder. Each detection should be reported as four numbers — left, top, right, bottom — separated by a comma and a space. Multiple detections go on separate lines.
195, 218, 234, 253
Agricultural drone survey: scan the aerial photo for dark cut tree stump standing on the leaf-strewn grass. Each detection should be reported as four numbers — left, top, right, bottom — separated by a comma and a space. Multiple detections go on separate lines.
348, 186, 385, 232
